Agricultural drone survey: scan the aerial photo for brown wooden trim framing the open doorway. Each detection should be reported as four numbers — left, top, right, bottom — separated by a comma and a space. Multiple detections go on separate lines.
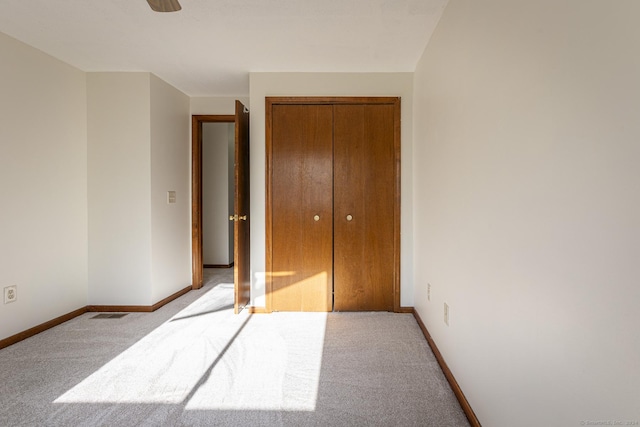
191, 115, 236, 289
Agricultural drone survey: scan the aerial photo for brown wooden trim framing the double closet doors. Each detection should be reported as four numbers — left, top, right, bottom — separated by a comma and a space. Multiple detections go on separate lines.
265, 96, 403, 313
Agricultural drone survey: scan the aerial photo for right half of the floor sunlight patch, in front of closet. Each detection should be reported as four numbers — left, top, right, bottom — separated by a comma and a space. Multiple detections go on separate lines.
186, 313, 327, 411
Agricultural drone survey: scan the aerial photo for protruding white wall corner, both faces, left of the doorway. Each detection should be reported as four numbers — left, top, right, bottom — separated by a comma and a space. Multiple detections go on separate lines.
87, 72, 191, 305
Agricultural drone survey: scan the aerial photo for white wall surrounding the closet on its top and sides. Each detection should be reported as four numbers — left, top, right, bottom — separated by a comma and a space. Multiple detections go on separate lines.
249, 73, 413, 307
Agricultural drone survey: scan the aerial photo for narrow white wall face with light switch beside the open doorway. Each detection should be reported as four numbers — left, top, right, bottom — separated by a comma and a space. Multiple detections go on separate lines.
150, 74, 191, 303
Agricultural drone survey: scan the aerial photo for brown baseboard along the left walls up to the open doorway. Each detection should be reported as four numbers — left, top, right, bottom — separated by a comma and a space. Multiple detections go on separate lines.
0, 286, 191, 349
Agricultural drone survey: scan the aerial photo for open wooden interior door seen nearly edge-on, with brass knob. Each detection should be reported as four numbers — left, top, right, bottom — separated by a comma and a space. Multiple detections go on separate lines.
233, 101, 251, 314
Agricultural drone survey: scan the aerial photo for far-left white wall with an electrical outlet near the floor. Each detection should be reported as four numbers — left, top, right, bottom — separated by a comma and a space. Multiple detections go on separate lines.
0, 33, 87, 339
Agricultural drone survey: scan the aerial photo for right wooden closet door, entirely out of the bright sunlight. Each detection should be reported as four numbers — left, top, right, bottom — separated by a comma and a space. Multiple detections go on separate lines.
334, 104, 396, 311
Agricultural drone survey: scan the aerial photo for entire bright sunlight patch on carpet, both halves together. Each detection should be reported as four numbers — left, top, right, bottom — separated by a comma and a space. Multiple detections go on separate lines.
54, 284, 327, 411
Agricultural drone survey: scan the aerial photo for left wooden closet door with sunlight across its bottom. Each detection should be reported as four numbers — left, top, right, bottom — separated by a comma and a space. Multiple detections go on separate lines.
271, 105, 333, 311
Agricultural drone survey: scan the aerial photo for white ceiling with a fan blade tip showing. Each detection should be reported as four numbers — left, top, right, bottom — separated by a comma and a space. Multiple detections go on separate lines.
0, 0, 447, 96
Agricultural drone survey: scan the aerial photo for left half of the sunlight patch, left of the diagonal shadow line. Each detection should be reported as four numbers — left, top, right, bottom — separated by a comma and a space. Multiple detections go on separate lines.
55, 286, 242, 404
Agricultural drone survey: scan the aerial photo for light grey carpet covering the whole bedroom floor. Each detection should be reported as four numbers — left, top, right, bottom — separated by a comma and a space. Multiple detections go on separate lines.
0, 270, 469, 426
